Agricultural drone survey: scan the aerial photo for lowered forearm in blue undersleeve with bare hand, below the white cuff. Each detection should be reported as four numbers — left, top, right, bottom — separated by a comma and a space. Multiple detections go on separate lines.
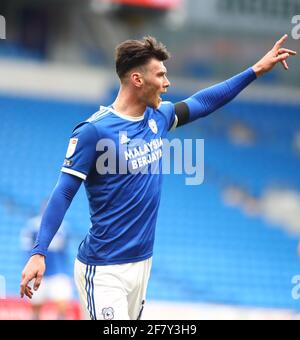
20, 173, 82, 298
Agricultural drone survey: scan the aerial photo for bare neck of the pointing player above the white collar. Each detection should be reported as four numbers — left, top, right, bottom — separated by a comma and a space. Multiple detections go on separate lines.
112, 88, 146, 118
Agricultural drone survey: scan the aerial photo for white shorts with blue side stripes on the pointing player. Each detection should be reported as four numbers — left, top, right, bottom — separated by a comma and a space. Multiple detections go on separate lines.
74, 258, 152, 320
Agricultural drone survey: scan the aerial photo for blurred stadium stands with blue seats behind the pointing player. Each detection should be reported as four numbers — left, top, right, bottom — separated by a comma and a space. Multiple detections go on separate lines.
0, 0, 300, 320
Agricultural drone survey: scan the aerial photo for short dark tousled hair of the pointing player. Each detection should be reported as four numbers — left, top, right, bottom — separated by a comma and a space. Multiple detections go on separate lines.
115, 36, 170, 79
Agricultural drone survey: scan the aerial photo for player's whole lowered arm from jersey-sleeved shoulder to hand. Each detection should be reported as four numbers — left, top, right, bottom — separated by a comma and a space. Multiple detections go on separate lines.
20, 124, 98, 298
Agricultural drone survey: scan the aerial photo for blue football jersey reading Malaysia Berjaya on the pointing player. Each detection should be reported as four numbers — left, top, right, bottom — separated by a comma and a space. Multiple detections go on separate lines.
62, 102, 177, 265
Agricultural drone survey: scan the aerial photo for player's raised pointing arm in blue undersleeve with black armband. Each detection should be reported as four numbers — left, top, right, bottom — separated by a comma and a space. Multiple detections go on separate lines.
175, 35, 297, 127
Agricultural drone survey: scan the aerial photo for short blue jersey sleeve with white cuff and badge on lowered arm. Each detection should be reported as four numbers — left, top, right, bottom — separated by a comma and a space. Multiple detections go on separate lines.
61, 123, 99, 180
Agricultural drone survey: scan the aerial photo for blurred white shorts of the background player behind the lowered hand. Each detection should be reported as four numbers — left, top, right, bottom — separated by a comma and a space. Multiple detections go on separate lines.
31, 274, 73, 305
